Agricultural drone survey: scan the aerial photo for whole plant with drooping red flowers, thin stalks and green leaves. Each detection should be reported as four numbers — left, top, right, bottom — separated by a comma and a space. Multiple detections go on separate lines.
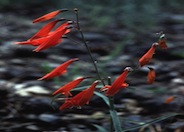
16, 8, 181, 132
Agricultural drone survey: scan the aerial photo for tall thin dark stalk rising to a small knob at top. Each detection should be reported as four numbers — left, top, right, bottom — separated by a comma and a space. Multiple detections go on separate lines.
74, 8, 105, 86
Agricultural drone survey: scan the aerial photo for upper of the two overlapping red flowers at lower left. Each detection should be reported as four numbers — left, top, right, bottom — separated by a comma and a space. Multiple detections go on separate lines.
52, 77, 89, 97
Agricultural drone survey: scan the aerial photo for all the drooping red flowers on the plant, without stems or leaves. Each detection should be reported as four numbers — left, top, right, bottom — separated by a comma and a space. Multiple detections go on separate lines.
16, 9, 170, 110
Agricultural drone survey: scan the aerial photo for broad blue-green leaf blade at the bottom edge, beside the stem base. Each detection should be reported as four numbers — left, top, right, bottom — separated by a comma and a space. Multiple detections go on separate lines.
110, 110, 122, 132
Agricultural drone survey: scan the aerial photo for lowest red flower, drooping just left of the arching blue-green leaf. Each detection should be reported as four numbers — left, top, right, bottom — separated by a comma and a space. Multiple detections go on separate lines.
59, 81, 99, 110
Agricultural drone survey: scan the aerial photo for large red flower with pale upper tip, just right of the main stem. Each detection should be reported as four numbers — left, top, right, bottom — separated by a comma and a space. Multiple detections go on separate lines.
102, 67, 132, 96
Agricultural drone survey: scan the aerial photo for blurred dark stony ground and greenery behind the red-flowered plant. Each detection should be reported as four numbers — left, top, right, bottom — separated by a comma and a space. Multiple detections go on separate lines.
0, 0, 184, 132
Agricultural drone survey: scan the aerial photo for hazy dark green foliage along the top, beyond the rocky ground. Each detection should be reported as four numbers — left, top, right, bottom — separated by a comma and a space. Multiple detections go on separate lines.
0, 0, 184, 30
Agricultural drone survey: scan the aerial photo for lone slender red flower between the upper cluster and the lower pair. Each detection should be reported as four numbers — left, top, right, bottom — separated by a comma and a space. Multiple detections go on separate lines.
38, 58, 79, 80
